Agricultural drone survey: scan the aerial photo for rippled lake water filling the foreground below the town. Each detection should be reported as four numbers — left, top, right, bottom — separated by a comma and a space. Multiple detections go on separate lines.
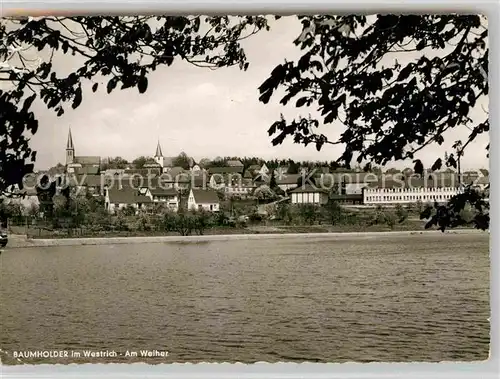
0, 234, 490, 363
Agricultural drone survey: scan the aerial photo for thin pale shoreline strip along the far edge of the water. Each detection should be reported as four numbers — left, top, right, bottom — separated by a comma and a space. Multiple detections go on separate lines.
4, 229, 490, 250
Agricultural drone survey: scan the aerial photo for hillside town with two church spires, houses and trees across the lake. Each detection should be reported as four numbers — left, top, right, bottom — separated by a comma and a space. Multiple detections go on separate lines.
3, 129, 489, 236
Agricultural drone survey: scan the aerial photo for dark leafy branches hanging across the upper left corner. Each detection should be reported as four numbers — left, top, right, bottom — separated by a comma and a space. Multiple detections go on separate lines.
0, 16, 267, 193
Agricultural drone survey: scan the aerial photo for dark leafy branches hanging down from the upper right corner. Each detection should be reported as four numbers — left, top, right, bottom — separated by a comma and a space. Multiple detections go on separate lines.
259, 15, 489, 230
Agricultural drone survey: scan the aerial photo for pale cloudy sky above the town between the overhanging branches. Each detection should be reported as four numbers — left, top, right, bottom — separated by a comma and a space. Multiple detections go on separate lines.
22, 18, 488, 169
